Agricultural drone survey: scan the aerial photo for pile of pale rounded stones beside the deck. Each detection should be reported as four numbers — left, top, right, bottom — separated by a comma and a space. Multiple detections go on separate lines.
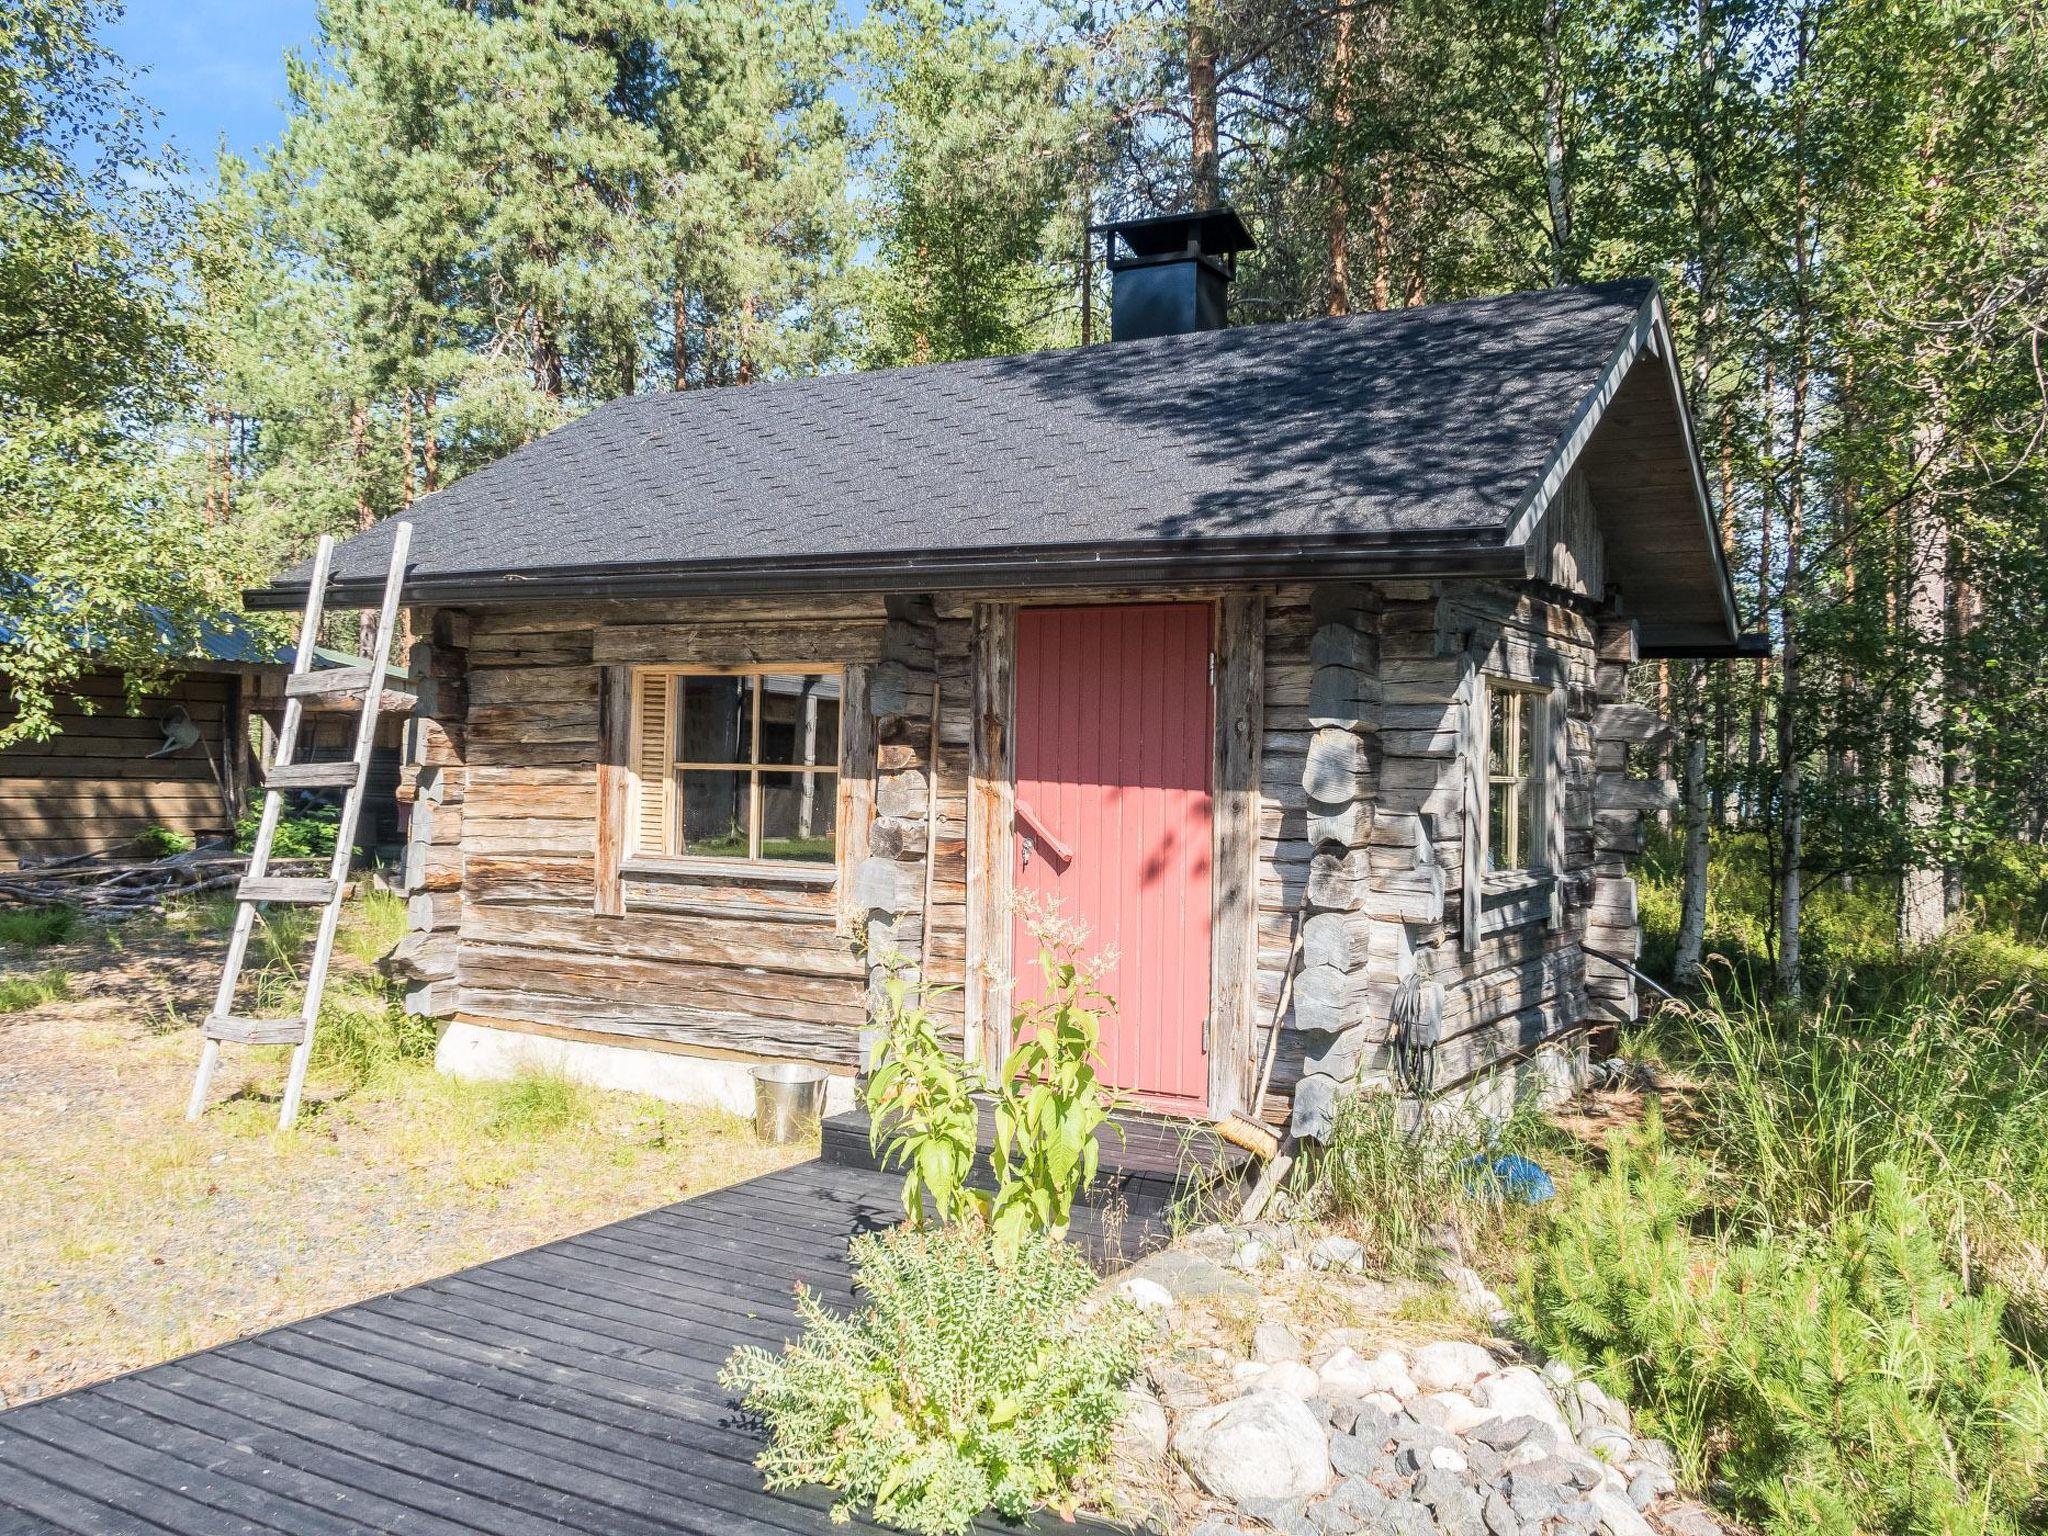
1122, 1233, 1722, 1536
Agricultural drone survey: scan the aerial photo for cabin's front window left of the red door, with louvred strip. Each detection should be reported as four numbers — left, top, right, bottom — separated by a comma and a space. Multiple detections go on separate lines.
633, 668, 846, 866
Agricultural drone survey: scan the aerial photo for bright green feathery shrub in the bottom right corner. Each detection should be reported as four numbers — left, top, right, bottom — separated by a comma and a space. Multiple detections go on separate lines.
1524, 1118, 2048, 1536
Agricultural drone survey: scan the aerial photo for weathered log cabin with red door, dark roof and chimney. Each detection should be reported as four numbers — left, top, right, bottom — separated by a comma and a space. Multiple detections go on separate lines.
252, 211, 1745, 1137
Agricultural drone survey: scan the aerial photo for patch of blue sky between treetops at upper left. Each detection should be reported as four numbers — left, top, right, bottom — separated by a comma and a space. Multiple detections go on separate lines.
104, 0, 313, 172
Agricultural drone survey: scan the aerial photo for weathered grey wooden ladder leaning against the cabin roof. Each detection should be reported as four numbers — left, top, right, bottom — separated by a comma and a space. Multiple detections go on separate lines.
184, 522, 412, 1130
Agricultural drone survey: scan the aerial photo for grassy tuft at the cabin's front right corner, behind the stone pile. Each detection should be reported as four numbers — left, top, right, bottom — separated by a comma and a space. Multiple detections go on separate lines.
1290, 1094, 1565, 1278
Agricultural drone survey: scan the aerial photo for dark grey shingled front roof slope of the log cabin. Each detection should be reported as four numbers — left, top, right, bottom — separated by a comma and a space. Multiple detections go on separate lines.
284, 281, 1653, 598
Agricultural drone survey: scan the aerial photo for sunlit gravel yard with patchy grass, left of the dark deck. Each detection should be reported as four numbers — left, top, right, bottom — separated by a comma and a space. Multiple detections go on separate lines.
0, 909, 809, 1405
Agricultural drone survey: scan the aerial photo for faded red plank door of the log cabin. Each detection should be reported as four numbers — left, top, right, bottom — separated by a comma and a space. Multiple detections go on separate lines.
1012, 602, 1214, 1110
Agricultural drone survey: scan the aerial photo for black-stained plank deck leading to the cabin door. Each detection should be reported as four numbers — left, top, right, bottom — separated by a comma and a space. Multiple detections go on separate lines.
0, 1122, 1212, 1536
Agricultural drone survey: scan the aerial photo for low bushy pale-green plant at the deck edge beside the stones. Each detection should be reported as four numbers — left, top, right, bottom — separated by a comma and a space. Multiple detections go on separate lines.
719, 1225, 1143, 1536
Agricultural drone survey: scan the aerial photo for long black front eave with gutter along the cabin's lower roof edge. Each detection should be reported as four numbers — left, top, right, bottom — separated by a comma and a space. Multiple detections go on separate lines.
244, 535, 1522, 610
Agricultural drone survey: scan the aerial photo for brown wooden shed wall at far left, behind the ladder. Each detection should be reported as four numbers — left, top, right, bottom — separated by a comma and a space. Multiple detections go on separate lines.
0, 672, 238, 862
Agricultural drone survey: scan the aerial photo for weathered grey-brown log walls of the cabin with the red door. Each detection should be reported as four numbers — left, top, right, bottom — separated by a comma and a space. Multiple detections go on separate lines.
399, 551, 1653, 1133
